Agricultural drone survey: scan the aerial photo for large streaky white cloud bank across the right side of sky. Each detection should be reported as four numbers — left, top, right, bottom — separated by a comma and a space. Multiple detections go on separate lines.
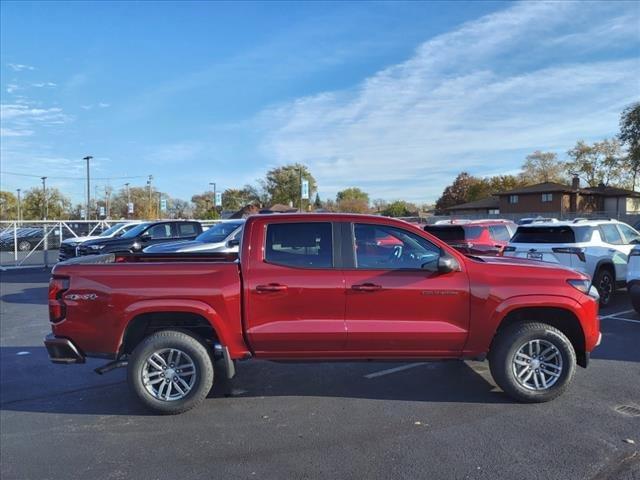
259, 2, 640, 201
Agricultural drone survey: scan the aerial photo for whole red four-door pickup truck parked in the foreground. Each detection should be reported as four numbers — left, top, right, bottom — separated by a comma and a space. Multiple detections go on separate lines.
45, 214, 600, 413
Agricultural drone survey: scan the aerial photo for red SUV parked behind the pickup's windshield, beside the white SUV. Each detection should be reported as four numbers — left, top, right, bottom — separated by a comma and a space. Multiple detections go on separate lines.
424, 220, 517, 255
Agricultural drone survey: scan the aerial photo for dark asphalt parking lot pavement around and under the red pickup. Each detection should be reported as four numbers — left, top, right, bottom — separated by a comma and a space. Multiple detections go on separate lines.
0, 269, 640, 480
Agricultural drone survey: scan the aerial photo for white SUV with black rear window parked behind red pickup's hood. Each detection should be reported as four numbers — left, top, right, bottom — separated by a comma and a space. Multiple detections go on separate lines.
504, 219, 640, 305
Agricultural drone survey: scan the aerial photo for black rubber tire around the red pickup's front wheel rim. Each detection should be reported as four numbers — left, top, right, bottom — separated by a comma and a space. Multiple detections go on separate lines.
489, 322, 576, 403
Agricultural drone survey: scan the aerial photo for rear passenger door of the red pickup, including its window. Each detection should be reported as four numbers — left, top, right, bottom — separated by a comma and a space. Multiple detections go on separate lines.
243, 218, 346, 358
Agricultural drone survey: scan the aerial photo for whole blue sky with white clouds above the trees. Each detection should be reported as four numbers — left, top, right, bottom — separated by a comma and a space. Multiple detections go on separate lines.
0, 1, 640, 202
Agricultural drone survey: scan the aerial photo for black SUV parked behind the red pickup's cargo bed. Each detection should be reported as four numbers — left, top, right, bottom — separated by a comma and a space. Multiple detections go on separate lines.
78, 220, 202, 255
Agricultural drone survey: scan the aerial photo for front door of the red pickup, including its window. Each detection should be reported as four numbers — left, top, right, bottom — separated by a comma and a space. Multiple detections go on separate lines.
344, 223, 469, 357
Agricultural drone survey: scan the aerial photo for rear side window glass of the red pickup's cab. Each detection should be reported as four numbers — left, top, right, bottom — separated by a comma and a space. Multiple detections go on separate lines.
264, 222, 333, 268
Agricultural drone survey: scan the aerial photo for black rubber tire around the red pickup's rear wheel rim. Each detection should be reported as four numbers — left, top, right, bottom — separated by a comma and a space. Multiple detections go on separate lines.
127, 330, 214, 415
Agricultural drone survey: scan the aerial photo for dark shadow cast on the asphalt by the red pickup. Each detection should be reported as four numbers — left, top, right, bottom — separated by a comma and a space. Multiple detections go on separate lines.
0, 347, 511, 416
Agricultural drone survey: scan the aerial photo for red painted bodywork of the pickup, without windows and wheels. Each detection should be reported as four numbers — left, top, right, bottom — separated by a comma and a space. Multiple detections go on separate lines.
50, 214, 599, 359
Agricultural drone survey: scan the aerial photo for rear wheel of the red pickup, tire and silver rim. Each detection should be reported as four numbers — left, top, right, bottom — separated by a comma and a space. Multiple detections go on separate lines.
127, 330, 213, 415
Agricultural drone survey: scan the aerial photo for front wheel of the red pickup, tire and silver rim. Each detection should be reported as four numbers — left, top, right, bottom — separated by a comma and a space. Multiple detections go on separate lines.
489, 322, 576, 403
